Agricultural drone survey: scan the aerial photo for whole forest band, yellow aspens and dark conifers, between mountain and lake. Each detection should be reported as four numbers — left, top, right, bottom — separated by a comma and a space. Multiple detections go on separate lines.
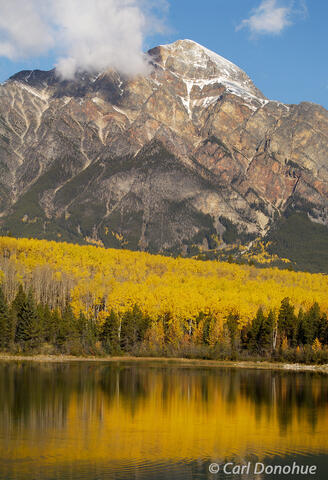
0, 237, 328, 363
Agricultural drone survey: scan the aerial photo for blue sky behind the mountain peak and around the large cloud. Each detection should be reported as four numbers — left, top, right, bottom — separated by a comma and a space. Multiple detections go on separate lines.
0, 0, 328, 108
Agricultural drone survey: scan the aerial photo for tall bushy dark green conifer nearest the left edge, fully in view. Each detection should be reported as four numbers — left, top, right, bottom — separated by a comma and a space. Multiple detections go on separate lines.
13, 287, 41, 350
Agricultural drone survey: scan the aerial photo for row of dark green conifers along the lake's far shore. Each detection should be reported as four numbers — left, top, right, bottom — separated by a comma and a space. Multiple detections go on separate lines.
0, 285, 328, 363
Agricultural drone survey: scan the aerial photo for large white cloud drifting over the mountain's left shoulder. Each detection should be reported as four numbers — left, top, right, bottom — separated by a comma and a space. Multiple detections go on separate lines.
0, 0, 167, 79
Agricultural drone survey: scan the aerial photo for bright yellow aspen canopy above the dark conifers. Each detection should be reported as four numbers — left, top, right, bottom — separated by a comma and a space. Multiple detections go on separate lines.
0, 237, 328, 328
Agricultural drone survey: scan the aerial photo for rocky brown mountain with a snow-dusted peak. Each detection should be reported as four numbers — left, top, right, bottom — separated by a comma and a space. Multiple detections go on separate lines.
0, 40, 328, 271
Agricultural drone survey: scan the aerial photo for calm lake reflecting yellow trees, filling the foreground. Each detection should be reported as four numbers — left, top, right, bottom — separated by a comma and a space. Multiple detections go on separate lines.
0, 362, 328, 480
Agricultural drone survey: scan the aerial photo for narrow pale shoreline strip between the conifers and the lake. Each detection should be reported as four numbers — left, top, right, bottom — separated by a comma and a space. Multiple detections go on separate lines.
0, 353, 328, 374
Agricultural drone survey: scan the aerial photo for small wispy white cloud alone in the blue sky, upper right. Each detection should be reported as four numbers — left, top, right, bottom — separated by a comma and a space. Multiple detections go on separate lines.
237, 0, 307, 35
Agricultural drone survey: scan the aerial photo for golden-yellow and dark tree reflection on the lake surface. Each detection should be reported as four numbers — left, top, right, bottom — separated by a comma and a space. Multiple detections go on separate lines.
0, 366, 328, 465
